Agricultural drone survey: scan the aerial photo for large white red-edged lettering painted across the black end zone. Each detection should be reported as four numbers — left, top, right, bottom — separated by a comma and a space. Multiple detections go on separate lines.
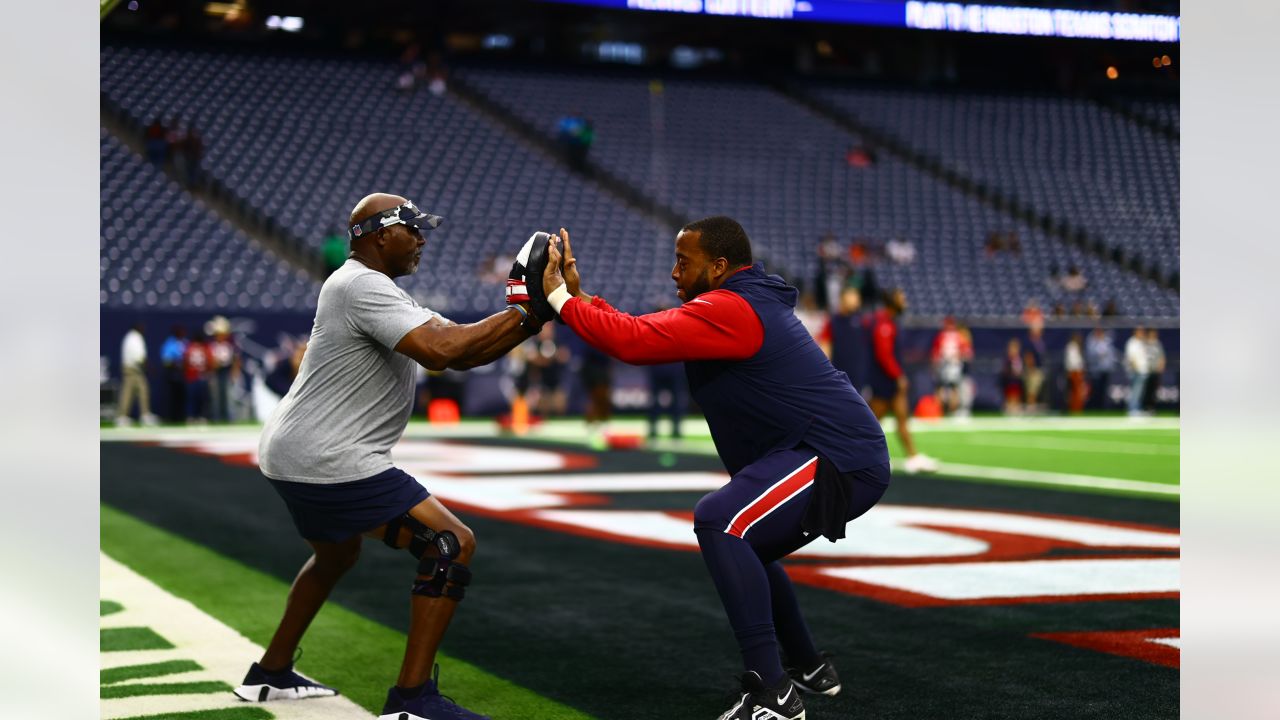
152, 439, 1180, 607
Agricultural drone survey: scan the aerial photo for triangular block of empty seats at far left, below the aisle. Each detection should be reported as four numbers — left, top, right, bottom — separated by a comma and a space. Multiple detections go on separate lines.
99, 129, 320, 310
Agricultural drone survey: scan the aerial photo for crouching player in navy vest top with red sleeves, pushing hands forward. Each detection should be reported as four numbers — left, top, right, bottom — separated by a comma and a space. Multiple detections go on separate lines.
543, 217, 890, 720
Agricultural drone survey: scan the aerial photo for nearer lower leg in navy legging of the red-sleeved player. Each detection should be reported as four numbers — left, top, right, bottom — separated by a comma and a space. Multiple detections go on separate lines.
696, 528, 786, 687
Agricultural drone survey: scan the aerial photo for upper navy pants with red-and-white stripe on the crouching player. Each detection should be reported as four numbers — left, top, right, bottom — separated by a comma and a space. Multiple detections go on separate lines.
694, 446, 890, 562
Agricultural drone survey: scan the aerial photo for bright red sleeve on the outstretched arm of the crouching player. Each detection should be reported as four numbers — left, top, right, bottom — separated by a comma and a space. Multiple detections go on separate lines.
561, 290, 764, 365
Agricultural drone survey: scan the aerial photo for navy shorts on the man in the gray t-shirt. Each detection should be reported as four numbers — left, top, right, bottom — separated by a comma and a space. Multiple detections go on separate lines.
268, 468, 431, 542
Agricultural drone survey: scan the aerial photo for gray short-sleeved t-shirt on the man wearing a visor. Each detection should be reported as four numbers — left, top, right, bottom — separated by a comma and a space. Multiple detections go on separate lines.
257, 260, 443, 484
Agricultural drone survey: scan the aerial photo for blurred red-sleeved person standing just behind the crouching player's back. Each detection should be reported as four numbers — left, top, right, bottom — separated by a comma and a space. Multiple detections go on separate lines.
868, 287, 938, 473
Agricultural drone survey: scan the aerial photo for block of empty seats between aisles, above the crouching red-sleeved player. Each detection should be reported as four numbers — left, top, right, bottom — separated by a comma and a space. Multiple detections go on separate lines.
456, 67, 1178, 316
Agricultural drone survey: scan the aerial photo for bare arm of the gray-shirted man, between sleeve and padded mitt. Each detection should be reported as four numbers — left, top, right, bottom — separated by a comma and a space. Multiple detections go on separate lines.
396, 307, 530, 370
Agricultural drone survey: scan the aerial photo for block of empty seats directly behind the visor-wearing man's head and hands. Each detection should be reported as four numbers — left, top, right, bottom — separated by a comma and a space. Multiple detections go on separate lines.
101, 46, 672, 315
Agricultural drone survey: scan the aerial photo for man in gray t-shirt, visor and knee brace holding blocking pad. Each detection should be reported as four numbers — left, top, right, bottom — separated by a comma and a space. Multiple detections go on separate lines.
236, 193, 540, 720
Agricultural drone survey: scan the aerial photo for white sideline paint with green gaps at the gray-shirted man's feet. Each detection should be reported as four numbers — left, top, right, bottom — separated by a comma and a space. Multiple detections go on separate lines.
99, 553, 371, 720
